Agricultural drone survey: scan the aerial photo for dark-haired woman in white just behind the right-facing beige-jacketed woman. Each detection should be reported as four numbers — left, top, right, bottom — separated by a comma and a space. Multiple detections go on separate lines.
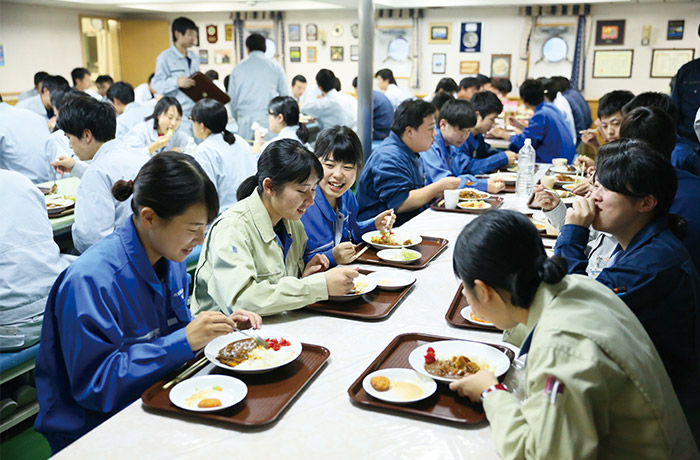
253, 96, 309, 153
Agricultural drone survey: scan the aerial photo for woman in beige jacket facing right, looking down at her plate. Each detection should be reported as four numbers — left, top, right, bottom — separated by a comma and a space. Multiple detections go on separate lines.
191, 139, 358, 315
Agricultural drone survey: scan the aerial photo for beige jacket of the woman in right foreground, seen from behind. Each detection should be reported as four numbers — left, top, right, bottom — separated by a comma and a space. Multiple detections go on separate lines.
484, 275, 699, 460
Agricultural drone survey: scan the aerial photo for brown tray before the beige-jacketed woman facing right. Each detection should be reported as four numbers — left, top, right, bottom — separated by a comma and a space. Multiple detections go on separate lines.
306, 270, 416, 321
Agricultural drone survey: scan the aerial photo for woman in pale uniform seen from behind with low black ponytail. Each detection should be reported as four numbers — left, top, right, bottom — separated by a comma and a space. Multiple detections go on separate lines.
190, 99, 256, 214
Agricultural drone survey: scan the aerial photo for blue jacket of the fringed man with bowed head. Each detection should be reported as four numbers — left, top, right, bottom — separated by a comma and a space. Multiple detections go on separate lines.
420, 128, 488, 191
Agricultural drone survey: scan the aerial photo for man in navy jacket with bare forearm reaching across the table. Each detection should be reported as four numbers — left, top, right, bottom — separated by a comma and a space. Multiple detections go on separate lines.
358, 100, 461, 225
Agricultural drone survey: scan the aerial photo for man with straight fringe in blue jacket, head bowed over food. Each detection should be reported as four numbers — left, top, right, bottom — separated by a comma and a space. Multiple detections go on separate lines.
420, 96, 503, 193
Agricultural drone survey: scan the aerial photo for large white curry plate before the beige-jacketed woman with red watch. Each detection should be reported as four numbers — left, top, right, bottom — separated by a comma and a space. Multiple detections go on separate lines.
408, 340, 510, 383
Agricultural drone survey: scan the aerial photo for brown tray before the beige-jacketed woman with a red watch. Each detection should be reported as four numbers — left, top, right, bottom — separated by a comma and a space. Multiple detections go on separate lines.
348, 333, 515, 424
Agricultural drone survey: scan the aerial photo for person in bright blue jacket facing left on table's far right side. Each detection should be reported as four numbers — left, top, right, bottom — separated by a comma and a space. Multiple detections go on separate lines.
493, 80, 576, 163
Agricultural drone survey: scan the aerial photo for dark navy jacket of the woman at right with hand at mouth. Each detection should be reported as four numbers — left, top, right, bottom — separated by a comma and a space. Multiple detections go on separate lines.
554, 216, 700, 426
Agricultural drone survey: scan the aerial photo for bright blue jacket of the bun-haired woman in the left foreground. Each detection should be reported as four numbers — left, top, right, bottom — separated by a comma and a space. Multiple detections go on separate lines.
34, 218, 195, 453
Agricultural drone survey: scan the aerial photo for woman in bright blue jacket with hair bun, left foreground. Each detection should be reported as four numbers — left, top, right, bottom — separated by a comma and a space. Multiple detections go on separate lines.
35, 152, 261, 454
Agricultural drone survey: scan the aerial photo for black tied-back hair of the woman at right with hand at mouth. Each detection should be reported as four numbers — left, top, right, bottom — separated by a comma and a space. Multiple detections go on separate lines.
596, 139, 687, 239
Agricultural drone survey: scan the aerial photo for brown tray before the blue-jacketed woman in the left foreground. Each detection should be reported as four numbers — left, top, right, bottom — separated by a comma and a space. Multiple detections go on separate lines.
141, 343, 331, 427
